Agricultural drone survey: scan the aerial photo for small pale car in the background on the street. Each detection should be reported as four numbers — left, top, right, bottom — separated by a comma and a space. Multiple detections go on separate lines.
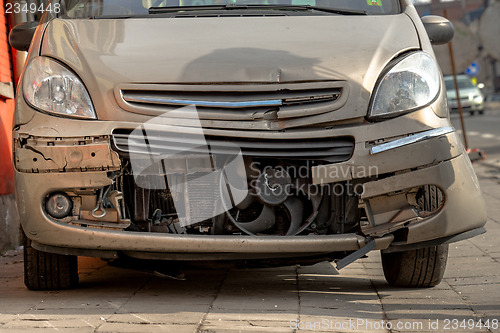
444, 74, 484, 116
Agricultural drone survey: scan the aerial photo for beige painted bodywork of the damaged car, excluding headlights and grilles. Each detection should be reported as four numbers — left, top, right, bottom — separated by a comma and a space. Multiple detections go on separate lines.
14, 0, 486, 258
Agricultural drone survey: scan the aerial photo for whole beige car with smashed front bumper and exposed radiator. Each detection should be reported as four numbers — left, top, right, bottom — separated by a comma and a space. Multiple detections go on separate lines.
13, 1, 486, 289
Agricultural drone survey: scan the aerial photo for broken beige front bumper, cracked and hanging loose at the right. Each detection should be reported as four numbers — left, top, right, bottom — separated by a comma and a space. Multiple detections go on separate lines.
14, 103, 486, 259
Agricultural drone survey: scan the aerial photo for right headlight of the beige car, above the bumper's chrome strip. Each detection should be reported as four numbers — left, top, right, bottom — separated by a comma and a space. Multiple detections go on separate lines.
369, 52, 440, 118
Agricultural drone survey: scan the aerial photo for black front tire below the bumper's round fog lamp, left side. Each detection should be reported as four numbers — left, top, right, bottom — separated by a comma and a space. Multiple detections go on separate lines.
24, 237, 78, 290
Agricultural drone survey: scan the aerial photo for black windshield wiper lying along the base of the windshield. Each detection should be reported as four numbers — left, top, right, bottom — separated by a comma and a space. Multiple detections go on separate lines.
149, 4, 366, 15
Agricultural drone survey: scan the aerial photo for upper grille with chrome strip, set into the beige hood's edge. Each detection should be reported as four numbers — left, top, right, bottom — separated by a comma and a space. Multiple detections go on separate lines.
115, 81, 348, 121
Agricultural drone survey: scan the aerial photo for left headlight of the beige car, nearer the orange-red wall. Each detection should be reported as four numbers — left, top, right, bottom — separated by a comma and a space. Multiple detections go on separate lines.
23, 57, 97, 119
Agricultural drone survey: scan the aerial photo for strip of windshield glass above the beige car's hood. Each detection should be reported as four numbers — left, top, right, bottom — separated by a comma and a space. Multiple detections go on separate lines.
61, 0, 399, 18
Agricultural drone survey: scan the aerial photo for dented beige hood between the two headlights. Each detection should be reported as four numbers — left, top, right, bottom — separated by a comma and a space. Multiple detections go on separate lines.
41, 14, 420, 120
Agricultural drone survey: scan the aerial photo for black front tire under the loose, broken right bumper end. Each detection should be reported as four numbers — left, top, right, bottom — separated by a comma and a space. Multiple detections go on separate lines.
382, 244, 448, 288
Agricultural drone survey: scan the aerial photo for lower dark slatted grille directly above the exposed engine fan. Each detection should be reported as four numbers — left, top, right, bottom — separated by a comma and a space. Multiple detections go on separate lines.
112, 129, 354, 162
